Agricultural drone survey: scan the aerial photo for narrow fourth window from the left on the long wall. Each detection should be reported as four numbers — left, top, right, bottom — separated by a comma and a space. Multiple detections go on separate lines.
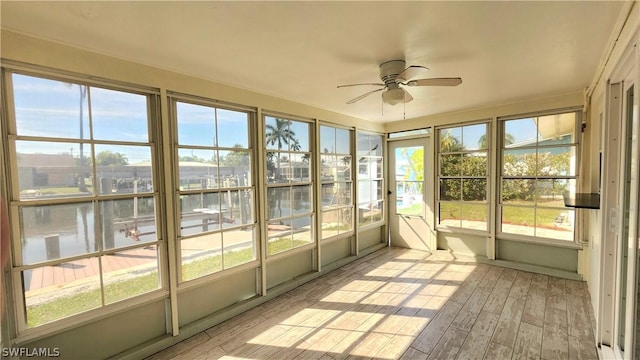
320, 126, 354, 239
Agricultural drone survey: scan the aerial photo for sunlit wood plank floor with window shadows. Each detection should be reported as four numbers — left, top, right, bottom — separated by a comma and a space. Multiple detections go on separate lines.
148, 248, 597, 360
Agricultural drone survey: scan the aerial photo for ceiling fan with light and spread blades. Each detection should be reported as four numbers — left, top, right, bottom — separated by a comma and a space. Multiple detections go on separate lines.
338, 60, 462, 105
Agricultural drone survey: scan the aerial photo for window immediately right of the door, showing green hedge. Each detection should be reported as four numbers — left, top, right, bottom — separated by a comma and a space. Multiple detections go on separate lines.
438, 123, 489, 231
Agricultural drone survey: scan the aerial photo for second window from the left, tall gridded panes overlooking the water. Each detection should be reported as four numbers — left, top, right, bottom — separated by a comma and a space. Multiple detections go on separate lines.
173, 100, 256, 281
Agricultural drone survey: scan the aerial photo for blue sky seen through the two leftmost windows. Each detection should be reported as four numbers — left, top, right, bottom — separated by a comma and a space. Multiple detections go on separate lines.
12, 74, 249, 164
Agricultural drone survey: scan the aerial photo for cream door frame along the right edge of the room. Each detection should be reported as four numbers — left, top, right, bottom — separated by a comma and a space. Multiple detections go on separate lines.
596, 32, 640, 359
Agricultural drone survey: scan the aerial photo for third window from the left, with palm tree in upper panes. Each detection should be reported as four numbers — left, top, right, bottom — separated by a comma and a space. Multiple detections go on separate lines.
265, 116, 314, 255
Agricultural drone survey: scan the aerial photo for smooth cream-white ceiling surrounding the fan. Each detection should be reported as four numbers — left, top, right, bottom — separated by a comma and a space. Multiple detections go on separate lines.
0, 1, 623, 122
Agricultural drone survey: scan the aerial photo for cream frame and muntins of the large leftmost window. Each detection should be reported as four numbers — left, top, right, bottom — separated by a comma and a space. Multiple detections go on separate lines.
2, 63, 168, 341
